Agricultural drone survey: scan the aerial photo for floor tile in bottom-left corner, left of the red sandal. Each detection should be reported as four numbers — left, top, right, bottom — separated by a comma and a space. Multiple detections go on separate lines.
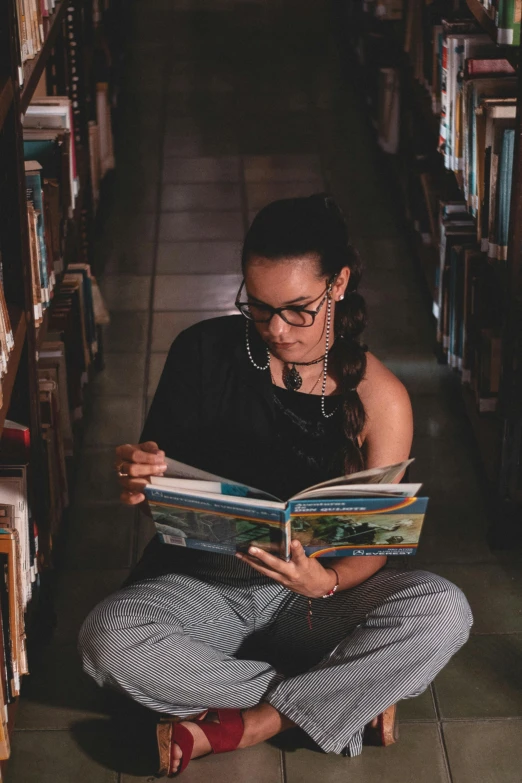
6, 723, 118, 783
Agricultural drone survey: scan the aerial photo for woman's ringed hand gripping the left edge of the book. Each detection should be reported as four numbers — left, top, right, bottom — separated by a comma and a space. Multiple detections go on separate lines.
116, 440, 167, 506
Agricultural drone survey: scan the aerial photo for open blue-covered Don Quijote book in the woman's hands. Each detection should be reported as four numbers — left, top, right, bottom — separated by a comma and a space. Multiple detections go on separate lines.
144, 459, 428, 560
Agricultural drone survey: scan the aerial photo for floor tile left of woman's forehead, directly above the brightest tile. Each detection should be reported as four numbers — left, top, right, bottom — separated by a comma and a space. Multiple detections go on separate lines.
156, 242, 241, 275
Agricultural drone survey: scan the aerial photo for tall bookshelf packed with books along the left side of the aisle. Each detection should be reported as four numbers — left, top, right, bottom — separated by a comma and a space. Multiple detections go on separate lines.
0, 0, 118, 764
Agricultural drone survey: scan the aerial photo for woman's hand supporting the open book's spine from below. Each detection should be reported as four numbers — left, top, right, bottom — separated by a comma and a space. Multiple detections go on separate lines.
236, 540, 337, 598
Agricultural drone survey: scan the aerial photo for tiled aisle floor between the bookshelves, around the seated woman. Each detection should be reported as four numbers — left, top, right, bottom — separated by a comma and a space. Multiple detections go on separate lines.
7, 0, 522, 783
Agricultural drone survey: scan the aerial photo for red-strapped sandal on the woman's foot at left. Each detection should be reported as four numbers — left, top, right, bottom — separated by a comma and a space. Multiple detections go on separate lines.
156, 710, 245, 778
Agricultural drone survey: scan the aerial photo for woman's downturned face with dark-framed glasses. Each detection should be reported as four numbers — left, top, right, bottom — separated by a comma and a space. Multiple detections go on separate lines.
241, 256, 350, 363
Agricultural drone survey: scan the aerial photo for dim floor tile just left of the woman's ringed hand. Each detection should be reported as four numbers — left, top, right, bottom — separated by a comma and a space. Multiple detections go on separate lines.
72, 447, 124, 506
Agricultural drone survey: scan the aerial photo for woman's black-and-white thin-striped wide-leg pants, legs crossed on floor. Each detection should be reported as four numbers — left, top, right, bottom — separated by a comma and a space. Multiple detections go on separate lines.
80, 560, 473, 756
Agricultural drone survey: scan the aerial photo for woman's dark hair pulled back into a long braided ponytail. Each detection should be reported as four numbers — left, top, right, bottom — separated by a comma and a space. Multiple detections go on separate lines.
241, 193, 367, 473
